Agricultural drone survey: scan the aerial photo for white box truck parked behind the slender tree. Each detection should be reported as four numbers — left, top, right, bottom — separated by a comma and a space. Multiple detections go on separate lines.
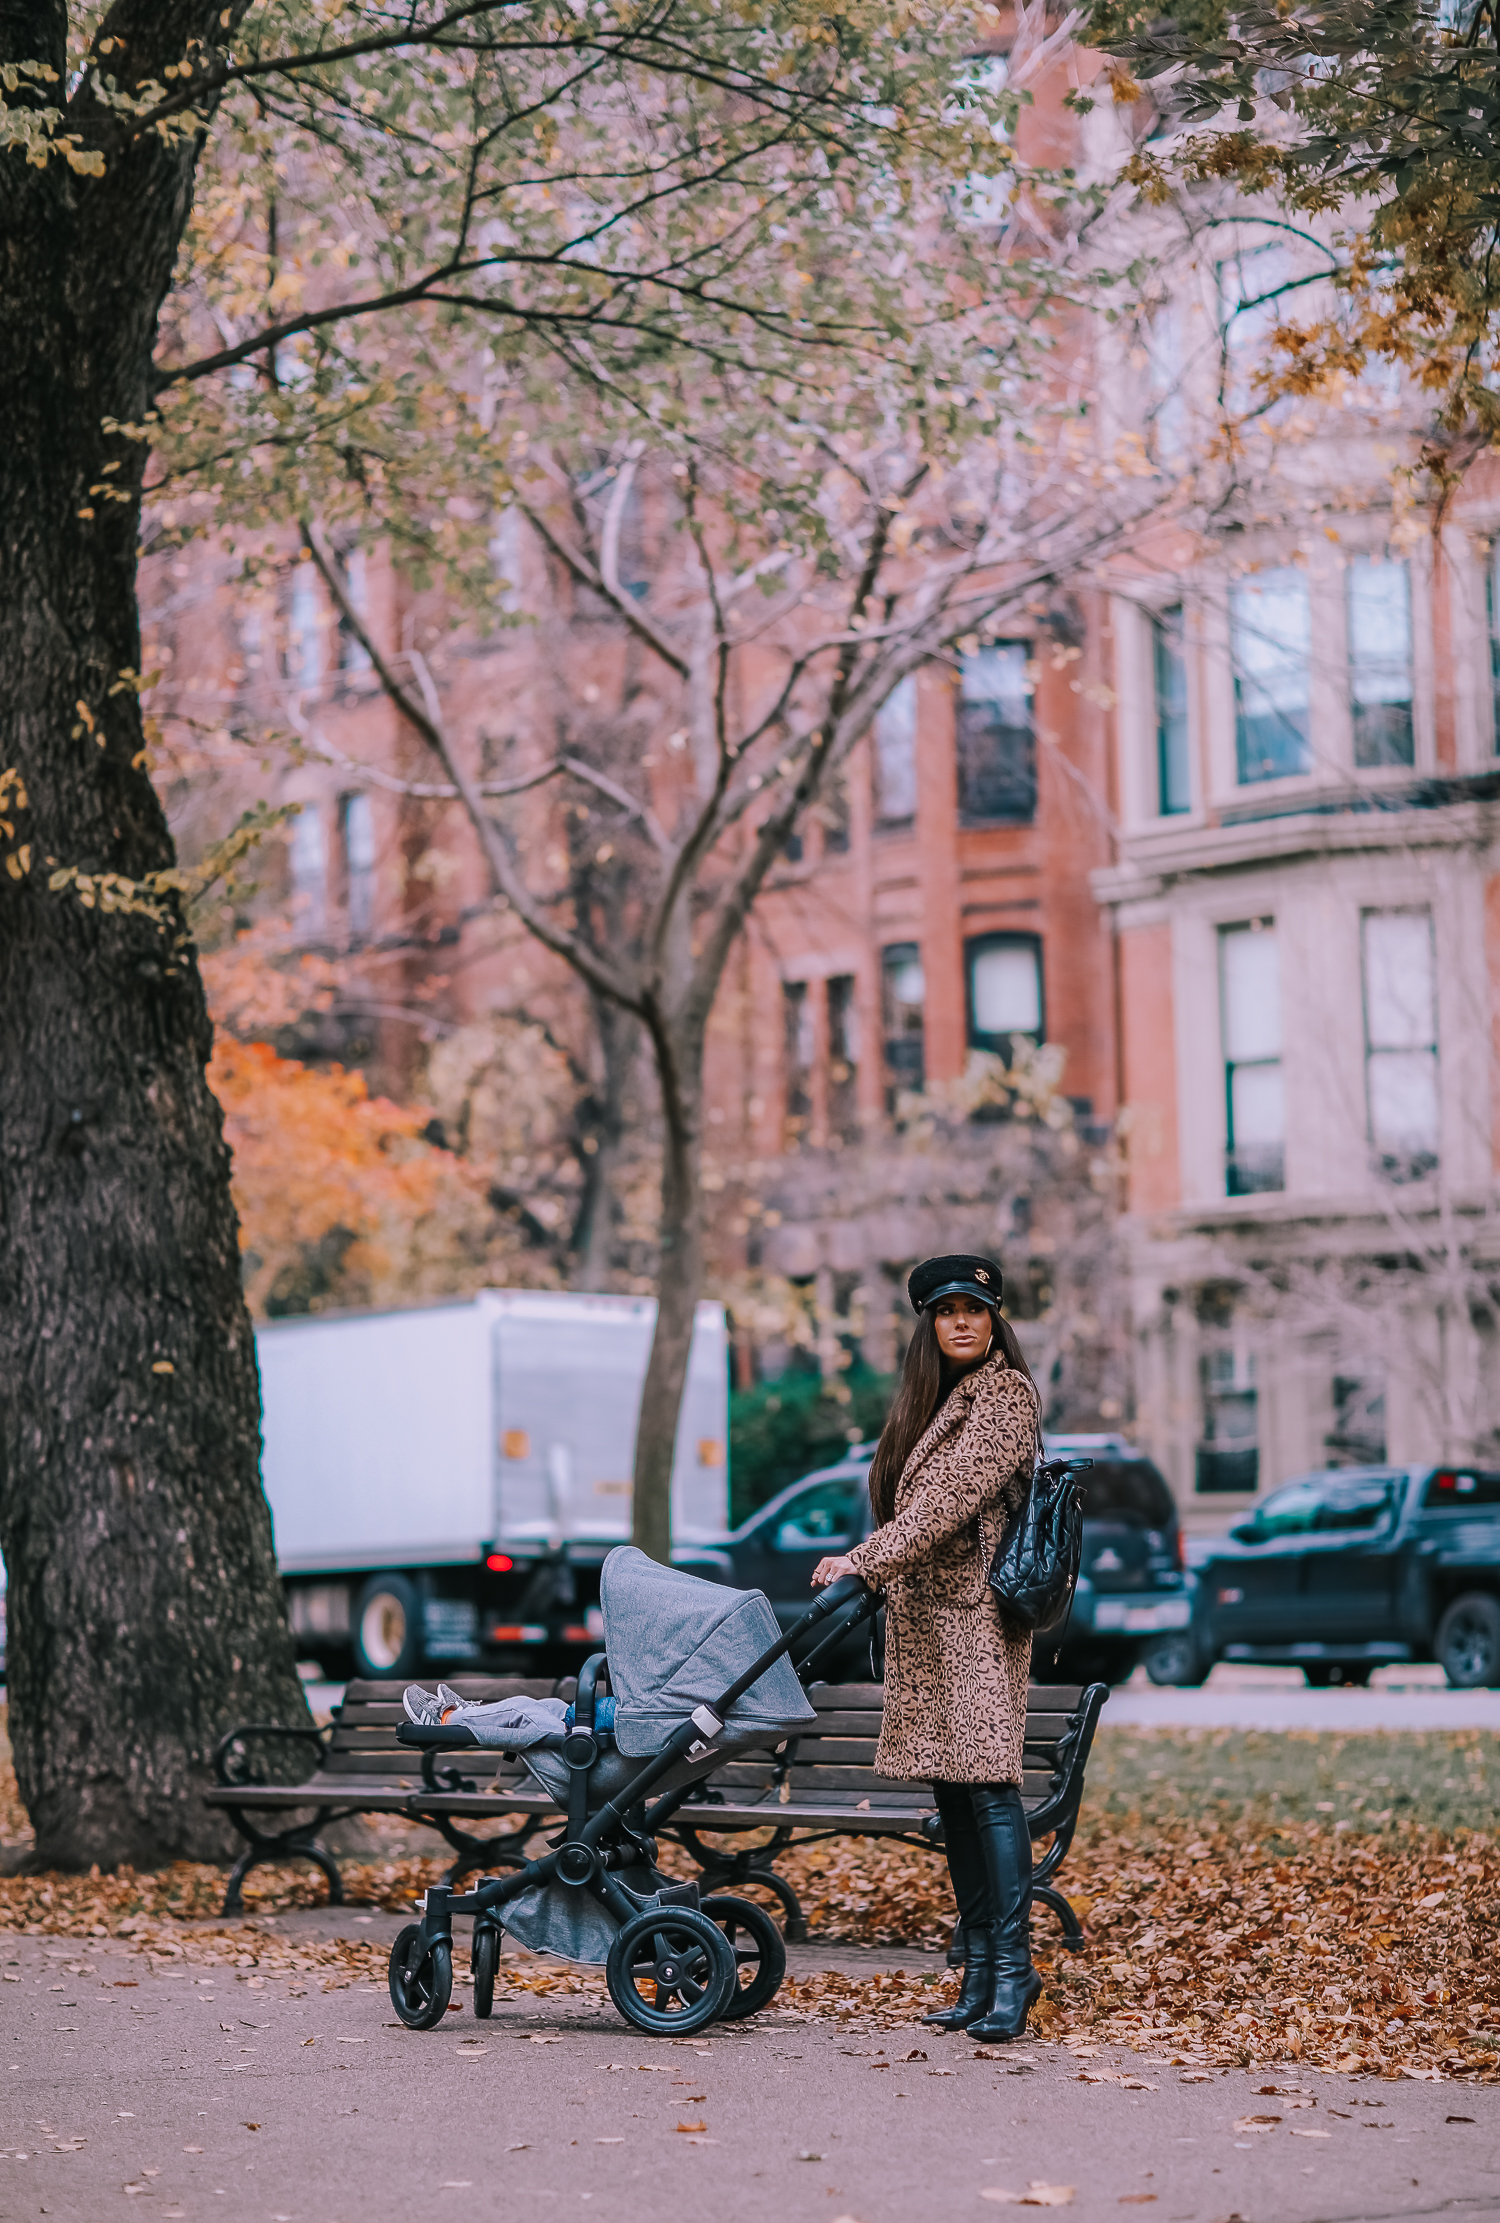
256, 1289, 729, 1676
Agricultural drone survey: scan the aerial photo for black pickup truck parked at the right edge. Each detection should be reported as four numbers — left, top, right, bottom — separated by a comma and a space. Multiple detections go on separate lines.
1189, 1465, 1500, 1689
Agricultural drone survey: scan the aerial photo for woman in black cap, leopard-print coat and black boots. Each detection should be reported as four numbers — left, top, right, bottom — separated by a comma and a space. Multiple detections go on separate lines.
813, 1258, 1042, 2041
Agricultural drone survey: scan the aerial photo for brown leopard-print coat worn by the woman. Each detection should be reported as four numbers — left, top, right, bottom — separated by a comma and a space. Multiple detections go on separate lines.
849, 1352, 1040, 1783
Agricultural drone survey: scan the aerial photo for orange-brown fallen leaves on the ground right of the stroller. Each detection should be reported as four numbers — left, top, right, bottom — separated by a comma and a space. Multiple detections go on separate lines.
755, 1778, 1500, 2083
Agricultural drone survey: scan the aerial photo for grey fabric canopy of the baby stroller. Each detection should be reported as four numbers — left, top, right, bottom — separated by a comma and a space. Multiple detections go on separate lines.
600, 1543, 818, 1761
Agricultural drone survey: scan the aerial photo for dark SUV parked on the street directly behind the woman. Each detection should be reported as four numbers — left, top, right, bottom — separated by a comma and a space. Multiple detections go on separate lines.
720, 1436, 1193, 1683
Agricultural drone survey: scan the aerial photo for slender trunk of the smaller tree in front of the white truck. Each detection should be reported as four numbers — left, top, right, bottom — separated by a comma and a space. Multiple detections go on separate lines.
631, 1023, 702, 1565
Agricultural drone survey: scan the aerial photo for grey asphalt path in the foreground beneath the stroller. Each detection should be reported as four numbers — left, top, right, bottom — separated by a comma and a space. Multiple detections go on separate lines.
0, 1916, 1500, 2223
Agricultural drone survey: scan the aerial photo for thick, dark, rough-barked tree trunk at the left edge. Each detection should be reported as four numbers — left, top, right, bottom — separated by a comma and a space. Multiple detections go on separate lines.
0, 0, 307, 1867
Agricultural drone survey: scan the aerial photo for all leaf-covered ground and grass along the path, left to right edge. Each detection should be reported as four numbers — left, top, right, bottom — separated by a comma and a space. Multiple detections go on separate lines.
0, 1729, 1500, 2083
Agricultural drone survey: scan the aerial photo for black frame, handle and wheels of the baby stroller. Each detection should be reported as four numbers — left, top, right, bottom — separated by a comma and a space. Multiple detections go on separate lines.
391, 1574, 878, 2032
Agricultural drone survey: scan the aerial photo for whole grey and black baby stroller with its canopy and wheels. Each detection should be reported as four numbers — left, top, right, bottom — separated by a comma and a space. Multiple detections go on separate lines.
389, 1545, 878, 2036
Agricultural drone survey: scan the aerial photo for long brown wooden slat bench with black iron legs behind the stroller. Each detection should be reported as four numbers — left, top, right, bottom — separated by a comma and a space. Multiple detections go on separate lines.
207, 1676, 1109, 1952
